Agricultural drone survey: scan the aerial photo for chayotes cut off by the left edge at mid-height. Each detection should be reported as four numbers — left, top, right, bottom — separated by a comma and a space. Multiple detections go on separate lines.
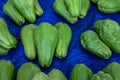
0, 18, 17, 55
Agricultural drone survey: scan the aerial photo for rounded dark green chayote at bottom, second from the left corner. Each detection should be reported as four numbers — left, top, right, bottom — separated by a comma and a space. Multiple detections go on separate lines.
16, 62, 41, 80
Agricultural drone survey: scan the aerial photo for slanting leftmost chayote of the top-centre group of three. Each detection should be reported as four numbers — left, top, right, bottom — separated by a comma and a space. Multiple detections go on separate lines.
53, 0, 78, 24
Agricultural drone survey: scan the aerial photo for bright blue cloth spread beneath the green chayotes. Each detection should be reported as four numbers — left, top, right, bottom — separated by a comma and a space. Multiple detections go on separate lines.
0, 0, 120, 79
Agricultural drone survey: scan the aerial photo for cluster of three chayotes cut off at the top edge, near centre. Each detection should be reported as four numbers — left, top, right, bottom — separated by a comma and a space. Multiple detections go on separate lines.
53, 0, 90, 24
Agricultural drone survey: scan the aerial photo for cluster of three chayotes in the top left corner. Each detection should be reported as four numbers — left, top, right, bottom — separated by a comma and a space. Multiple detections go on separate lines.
3, 0, 43, 25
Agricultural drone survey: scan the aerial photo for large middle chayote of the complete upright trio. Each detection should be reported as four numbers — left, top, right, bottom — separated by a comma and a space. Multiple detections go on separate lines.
34, 22, 58, 67
